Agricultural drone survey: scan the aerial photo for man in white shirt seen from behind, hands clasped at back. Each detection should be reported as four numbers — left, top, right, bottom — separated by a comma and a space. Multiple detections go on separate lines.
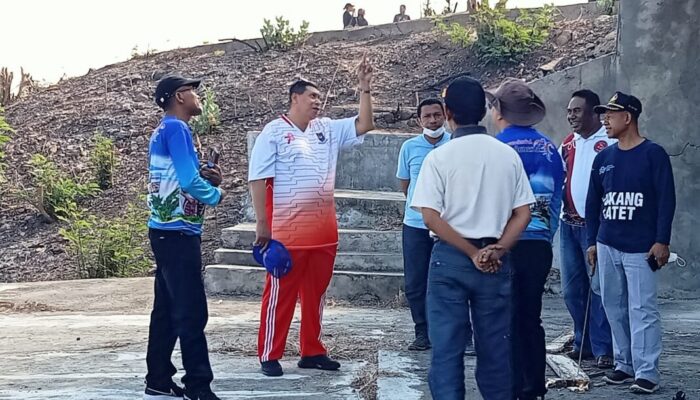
411, 78, 535, 400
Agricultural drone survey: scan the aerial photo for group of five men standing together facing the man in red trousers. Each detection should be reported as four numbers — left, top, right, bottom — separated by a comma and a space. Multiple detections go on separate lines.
397, 78, 675, 400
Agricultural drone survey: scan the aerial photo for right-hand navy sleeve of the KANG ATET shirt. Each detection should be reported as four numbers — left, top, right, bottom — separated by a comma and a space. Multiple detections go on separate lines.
652, 148, 676, 245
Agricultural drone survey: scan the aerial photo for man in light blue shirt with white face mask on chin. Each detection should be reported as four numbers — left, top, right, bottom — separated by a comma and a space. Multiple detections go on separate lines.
396, 99, 472, 350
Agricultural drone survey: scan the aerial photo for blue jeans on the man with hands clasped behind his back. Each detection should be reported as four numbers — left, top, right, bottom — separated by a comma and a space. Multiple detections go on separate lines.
427, 241, 513, 400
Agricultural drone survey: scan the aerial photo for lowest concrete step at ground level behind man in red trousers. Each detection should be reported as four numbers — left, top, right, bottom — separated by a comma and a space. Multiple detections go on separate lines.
204, 264, 403, 302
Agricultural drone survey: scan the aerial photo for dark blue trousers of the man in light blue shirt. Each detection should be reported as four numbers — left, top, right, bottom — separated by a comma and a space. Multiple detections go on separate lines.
402, 224, 472, 345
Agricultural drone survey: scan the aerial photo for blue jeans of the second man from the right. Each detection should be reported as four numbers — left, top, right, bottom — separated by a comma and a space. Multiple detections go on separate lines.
560, 222, 612, 357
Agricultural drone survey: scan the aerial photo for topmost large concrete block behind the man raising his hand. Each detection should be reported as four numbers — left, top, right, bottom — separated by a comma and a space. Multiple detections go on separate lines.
248, 132, 416, 191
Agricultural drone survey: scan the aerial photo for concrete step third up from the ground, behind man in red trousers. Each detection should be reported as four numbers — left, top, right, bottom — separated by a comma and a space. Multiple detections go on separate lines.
221, 222, 402, 253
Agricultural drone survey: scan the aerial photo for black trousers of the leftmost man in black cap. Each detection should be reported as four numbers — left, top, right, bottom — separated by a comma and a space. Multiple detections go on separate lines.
146, 229, 214, 391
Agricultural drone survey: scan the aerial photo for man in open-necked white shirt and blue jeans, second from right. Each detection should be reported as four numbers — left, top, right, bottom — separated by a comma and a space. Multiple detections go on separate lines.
559, 89, 617, 368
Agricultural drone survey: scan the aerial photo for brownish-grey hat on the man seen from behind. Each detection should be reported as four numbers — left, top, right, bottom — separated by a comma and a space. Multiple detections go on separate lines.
486, 78, 546, 126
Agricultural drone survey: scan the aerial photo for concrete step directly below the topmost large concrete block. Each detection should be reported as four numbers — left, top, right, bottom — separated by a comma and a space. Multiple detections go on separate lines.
241, 189, 406, 228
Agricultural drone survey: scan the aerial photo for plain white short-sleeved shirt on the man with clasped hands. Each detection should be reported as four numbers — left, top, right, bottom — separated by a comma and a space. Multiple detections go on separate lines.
411, 134, 535, 239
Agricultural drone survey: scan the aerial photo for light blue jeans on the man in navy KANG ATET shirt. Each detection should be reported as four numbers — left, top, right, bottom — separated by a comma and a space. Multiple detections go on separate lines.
598, 243, 661, 384
